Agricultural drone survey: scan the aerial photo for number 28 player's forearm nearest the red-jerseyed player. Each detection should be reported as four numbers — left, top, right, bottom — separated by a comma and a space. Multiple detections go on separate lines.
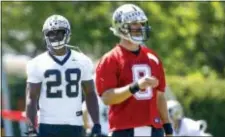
85, 91, 99, 124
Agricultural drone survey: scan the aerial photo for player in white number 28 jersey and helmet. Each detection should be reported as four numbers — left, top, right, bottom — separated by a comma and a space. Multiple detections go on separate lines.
26, 15, 101, 136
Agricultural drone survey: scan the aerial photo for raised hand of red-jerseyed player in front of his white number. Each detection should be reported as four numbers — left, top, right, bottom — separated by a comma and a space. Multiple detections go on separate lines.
138, 76, 159, 89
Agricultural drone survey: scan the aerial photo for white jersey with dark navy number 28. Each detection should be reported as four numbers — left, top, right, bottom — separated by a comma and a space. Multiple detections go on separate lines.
27, 50, 93, 125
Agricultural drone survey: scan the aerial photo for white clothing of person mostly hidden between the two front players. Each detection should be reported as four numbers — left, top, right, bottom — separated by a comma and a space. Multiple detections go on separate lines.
83, 96, 109, 135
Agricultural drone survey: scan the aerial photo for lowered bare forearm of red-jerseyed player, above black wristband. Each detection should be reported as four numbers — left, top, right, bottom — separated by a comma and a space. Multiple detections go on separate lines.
157, 92, 170, 123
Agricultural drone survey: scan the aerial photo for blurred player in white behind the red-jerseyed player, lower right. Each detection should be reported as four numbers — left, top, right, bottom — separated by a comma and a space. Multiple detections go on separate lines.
167, 100, 211, 136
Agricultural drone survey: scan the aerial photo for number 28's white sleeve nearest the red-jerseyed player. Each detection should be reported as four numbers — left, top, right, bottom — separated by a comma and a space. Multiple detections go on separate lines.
82, 58, 94, 81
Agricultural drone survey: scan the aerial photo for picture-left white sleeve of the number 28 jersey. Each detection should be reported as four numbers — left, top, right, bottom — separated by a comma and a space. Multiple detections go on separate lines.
26, 60, 42, 83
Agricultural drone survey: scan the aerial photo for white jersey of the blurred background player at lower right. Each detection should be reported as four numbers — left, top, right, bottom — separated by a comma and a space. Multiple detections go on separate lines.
174, 117, 209, 136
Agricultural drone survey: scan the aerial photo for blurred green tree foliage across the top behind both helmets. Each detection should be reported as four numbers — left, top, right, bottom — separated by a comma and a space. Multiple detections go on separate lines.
2, 1, 225, 77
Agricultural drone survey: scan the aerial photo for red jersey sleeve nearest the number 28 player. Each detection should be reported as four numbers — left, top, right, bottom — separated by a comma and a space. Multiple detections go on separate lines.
95, 56, 118, 96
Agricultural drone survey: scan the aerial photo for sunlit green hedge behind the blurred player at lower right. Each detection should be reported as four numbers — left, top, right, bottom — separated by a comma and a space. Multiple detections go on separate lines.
168, 74, 225, 136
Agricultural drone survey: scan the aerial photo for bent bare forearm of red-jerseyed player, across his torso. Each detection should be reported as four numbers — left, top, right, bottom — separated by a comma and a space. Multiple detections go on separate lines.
102, 85, 132, 105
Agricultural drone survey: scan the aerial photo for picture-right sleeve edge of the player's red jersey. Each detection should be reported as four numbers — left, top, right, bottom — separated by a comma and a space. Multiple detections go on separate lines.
157, 61, 166, 92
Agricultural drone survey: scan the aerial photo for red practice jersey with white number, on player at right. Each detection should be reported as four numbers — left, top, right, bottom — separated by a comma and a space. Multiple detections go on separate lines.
96, 45, 165, 131
